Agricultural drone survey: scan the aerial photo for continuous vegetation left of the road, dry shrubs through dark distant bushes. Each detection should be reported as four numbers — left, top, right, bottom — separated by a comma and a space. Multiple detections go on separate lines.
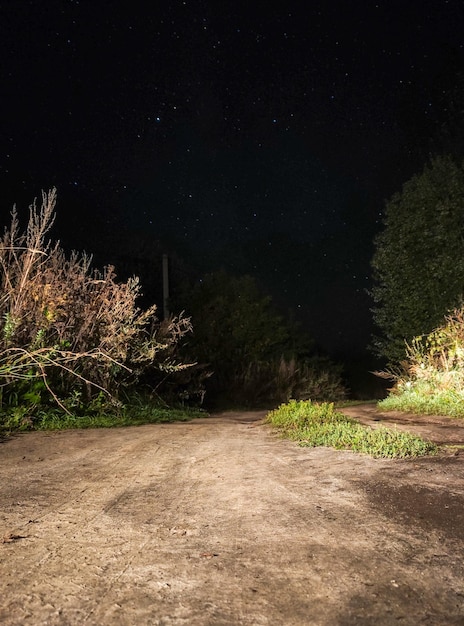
0, 189, 346, 432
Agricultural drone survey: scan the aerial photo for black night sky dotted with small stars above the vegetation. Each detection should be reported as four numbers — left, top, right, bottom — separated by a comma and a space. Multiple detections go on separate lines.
0, 0, 464, 353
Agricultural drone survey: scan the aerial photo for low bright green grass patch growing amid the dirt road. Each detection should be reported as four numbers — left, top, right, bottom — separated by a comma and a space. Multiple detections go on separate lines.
267, 400, 436, 458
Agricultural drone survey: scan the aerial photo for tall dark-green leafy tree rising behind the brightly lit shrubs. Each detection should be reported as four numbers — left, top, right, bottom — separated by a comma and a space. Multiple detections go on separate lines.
371, 156, 464, 363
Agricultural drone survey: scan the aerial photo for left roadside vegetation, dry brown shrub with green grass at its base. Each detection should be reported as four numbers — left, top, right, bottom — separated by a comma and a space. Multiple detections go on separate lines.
0, 189, 198, 430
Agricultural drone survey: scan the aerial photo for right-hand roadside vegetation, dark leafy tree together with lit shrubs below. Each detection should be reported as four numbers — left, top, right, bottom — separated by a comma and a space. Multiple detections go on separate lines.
371, 151, 464, 418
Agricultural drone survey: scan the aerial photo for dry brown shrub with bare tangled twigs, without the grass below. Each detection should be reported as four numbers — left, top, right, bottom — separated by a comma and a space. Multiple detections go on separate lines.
0, 189, 191, 408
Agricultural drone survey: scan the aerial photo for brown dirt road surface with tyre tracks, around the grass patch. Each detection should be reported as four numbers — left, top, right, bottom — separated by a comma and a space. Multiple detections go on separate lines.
0, 406, 464, 626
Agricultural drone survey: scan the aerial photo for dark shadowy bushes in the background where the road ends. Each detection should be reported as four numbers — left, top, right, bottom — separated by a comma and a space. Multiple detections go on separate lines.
179, 271, 345, 407
